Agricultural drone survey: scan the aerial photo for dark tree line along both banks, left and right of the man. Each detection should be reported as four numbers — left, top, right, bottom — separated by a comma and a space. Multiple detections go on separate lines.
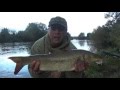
0, 12, 117, 46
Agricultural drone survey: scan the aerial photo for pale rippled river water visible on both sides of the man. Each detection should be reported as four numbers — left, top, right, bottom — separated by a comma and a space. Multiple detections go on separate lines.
0, 40, 91, 78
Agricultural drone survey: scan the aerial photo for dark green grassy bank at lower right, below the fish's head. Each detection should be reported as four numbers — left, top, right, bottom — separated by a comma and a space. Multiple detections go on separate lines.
85, 57, 120, 78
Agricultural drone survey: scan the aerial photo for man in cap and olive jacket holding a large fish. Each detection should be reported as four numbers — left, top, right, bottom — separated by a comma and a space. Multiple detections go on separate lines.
28, 16, 88, 78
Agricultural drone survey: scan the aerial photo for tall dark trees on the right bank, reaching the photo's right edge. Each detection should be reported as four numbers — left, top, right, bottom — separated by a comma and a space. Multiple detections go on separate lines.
90, 12, 120, 51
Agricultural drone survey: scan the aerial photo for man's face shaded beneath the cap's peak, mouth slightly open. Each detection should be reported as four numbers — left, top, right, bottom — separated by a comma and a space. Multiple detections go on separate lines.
49, 25, 67, 45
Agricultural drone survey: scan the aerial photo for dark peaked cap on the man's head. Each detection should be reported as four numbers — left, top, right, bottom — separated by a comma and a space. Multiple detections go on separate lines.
48, 16, 67, 30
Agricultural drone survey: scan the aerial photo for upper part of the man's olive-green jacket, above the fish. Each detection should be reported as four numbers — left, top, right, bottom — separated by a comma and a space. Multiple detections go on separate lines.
31, 34, 76, 54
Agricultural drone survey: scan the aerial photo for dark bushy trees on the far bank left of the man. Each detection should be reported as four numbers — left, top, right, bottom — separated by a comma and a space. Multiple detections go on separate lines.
0, 23, 47, 43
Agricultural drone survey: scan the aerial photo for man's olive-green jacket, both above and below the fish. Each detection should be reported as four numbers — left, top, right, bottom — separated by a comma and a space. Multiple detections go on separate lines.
28, 34, 84, 78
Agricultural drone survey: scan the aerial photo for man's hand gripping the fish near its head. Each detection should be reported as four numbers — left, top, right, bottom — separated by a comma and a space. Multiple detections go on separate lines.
75, 60, 89, 72
